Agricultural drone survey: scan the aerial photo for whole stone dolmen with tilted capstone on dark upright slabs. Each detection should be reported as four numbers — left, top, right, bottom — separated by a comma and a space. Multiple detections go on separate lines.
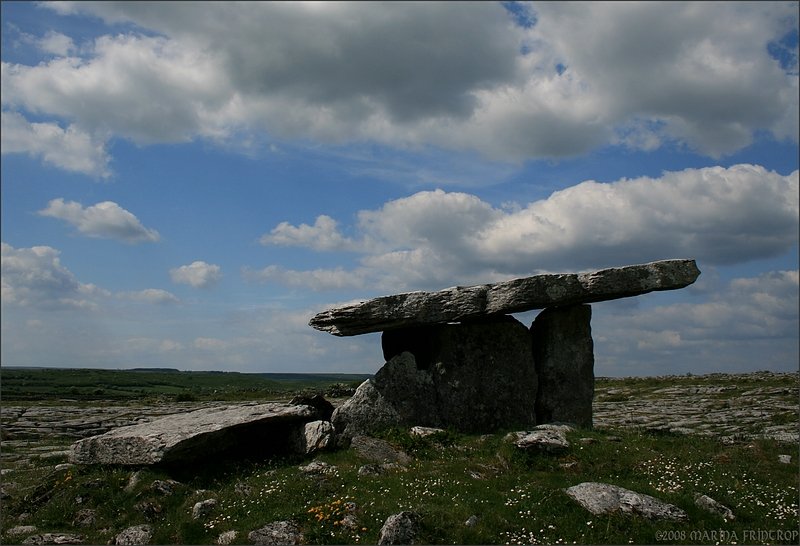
309, 259, 700, 437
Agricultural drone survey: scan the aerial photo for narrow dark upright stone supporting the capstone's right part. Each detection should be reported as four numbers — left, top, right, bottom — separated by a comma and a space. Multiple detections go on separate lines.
531, 305, 594, 428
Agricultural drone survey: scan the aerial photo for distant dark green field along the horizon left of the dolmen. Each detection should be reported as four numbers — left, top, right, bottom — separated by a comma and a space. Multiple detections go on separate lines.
0, 368, 369, 401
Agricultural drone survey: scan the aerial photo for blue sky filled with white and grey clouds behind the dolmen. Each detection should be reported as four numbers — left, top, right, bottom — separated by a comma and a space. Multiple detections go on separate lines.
0, 1, 800, 376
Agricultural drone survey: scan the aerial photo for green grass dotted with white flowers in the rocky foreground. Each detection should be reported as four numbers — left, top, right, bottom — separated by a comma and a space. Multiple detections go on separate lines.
2, 429, 800, 544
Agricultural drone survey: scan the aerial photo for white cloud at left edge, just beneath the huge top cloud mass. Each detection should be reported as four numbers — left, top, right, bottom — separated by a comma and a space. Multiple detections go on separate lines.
0, 111, 110, 178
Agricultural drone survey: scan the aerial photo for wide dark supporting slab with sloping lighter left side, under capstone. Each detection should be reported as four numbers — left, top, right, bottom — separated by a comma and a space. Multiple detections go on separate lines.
333, 316, 537, 435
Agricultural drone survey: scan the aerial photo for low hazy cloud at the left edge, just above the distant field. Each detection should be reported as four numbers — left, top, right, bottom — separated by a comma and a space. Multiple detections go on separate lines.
2, 243, 110, 311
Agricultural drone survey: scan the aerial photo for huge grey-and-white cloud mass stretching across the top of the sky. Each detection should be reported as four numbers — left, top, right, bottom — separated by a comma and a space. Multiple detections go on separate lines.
2, 2, 799, 170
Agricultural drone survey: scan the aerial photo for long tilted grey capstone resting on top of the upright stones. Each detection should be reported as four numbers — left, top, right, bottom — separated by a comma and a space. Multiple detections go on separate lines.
309, 259, 700, 336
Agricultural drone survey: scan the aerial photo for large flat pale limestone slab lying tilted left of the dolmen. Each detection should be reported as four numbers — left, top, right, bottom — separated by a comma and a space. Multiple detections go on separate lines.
70, 403, 316, 465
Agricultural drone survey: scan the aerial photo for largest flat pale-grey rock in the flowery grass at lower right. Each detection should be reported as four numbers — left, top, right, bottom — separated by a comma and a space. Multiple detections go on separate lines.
566, 482, 687, 521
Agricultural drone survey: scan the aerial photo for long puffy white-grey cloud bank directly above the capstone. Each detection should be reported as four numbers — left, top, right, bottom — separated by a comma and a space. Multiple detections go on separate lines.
261, 165, 800, 289
